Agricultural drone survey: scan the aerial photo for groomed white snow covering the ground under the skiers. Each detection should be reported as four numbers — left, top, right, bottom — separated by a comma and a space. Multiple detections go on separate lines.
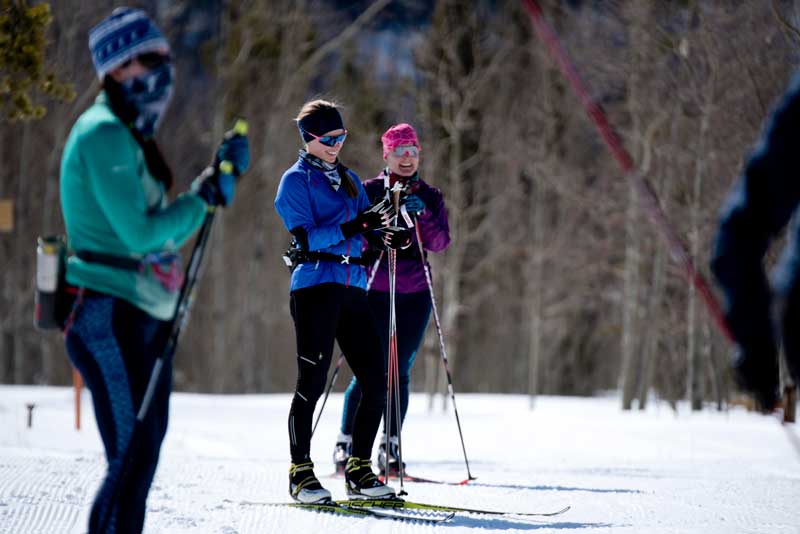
0, 386, 800, 534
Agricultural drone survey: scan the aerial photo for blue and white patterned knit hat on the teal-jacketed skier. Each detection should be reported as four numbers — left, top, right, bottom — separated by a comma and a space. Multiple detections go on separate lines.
89, 7, 169, 80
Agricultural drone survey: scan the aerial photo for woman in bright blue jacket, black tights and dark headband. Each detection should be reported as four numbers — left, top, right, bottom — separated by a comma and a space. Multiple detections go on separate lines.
275, 100, 410, 502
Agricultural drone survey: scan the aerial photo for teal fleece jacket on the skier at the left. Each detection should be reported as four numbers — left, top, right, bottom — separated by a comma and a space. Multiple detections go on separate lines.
61, 92, 206, 320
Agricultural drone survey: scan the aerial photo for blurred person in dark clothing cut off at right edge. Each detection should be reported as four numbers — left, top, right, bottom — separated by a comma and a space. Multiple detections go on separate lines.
711, 75, 800, 411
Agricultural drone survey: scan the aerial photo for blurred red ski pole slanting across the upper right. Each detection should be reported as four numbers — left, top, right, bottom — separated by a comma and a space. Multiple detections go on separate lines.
523, 0, 734, 342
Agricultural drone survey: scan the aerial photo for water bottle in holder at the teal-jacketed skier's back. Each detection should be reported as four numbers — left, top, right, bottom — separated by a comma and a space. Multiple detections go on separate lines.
33, 235, 67, 330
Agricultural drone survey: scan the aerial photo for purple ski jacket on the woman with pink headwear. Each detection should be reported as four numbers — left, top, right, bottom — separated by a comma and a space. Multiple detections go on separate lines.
364, 171, 450, 293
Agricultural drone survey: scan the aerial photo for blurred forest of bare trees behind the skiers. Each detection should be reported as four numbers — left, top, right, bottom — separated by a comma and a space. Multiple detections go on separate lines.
0, 0, 800, 414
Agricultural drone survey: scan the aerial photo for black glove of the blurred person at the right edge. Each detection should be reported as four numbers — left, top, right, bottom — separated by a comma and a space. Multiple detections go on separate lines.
731, 346, 779, 413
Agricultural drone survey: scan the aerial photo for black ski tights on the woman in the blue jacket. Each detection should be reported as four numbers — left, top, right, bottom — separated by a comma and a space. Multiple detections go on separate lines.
289, 283, 386, 463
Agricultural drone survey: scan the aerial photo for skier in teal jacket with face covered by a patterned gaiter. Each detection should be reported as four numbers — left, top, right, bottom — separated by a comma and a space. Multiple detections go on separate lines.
61, 8, 249, 534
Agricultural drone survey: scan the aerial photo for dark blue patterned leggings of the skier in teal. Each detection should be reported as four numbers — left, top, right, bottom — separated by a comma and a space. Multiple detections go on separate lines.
67, 296, 172, 534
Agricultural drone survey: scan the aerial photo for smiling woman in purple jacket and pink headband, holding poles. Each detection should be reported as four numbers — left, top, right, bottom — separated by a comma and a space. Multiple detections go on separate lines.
334, 123, 450, 473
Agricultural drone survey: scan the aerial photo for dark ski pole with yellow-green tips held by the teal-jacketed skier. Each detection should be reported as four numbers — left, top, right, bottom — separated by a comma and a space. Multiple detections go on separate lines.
100, 119, 248, 532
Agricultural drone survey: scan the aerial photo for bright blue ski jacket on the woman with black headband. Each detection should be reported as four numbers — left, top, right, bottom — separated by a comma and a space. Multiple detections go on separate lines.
275, 157, 370, 291
